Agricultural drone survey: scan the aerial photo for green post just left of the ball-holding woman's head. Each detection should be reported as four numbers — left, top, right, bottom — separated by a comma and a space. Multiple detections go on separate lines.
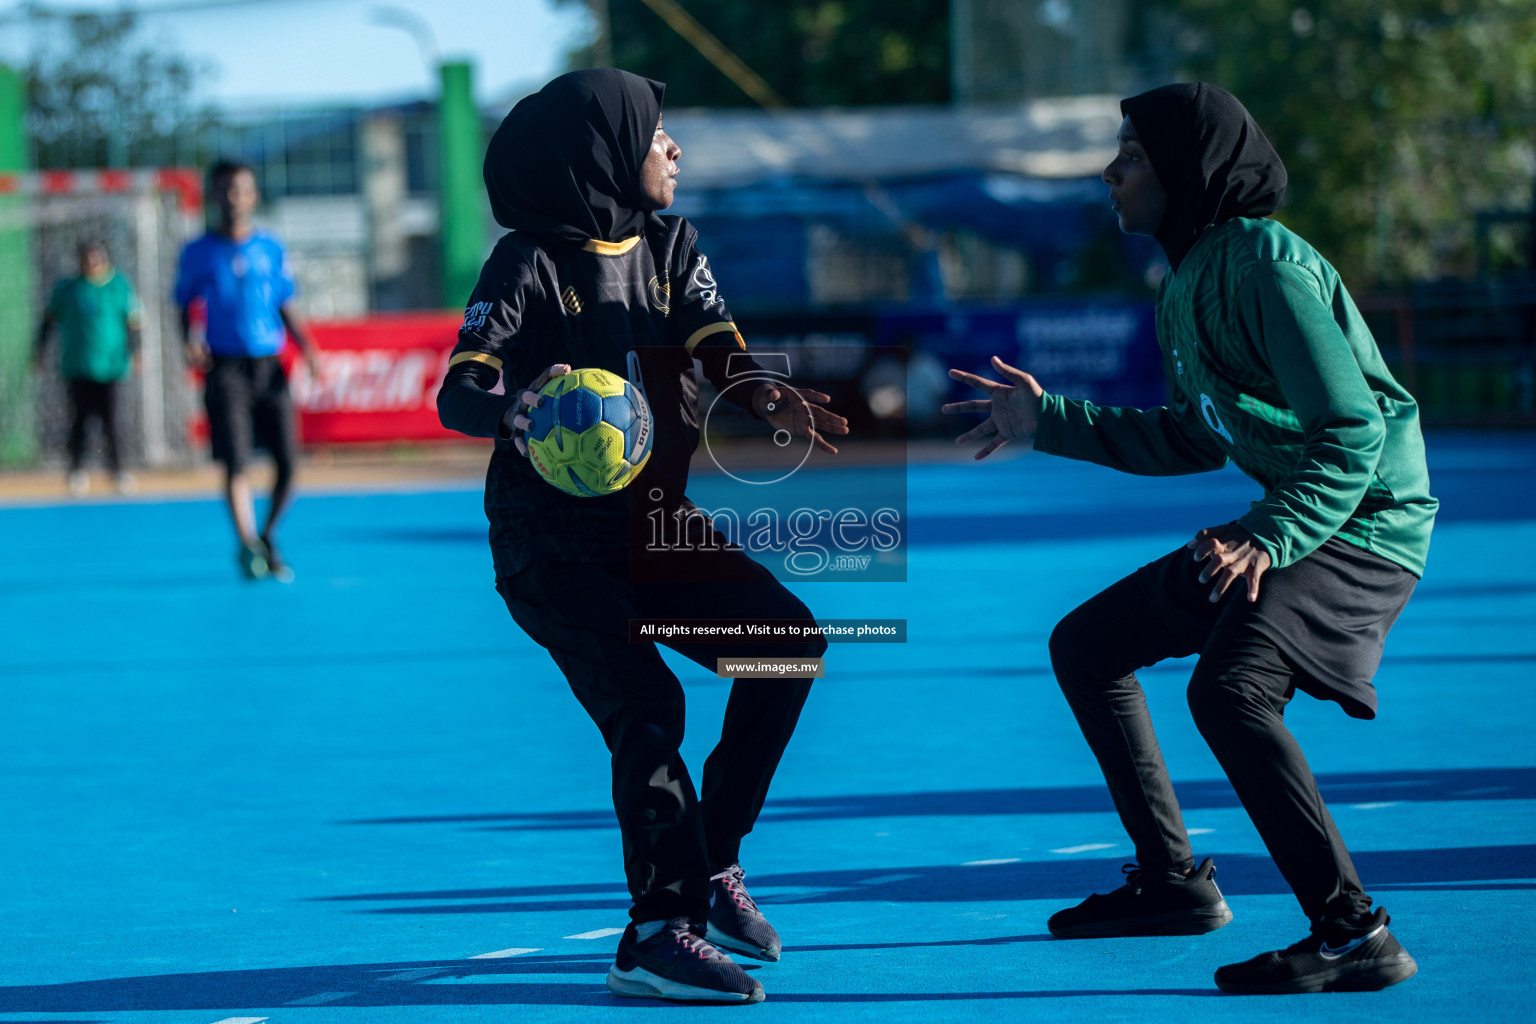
438, 63, 485, 309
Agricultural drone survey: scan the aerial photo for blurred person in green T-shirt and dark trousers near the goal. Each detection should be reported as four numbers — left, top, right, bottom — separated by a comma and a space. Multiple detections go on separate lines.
37, 239, 143, 497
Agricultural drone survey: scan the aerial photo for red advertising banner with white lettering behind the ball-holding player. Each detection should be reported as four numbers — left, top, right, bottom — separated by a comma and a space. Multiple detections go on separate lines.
287, 312, 479, 444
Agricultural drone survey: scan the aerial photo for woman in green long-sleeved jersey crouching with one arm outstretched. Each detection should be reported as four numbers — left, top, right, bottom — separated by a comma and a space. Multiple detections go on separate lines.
945, 84, 1438, 992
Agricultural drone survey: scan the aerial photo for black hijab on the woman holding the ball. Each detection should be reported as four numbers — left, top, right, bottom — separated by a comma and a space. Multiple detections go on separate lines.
485, 68, 667, 243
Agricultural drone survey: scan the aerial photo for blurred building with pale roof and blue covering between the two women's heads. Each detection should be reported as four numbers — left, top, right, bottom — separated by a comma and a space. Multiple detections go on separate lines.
667, 97, 1161, 310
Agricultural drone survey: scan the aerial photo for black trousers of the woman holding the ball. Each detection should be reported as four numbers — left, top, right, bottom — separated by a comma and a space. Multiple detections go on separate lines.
496, 550, 826, 921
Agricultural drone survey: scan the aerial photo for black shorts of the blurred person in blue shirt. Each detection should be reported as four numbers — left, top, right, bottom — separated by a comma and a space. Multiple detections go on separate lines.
203, 356, 298, 474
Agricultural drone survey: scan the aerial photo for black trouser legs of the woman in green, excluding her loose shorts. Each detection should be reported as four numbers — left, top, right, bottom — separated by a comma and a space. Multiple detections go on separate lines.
1051, 542, 1412, 920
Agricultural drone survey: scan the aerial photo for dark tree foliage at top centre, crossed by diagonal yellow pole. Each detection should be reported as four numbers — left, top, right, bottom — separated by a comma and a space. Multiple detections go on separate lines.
561, 0, 949, 106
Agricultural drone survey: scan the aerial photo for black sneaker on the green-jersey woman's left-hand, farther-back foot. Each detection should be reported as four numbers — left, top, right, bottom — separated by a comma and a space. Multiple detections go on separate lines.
1046, 857, 1232, 938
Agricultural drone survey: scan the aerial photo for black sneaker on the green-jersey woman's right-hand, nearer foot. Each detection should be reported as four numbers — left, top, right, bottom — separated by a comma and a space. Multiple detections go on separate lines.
1217, 907, 1419, 995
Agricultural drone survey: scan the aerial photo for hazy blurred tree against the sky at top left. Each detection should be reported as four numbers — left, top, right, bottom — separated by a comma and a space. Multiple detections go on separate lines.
26, 9, 217, 167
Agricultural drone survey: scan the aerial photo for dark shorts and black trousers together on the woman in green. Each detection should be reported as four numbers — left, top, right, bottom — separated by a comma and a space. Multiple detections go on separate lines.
1051, 539, 1416, 921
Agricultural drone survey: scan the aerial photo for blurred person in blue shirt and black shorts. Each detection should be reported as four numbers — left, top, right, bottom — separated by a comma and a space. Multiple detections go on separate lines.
175, 161, 319, 583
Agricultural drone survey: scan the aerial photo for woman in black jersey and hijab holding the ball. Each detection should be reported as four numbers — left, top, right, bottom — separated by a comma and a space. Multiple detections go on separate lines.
438, 69, 848, 1003
